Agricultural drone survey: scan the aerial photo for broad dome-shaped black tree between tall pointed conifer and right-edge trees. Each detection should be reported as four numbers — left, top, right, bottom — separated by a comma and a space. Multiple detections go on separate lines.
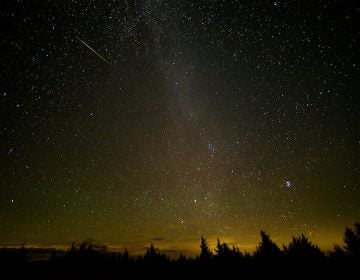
284, 234, 324, 259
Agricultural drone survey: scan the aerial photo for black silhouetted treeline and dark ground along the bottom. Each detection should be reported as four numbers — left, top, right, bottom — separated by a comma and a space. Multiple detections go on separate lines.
0, 223, 360, 279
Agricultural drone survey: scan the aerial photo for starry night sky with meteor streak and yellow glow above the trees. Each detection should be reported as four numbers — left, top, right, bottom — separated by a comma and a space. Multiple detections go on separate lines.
0, 0, 360, 255
